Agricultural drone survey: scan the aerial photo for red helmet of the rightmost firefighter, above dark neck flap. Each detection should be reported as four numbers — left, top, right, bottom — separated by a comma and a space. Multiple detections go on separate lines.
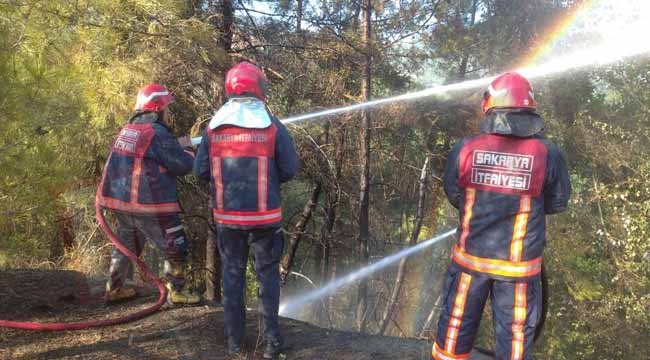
481, 72, 537, 114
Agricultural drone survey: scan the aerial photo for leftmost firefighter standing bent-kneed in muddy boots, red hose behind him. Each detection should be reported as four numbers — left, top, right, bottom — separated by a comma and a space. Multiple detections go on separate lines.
97, 83, 200, 304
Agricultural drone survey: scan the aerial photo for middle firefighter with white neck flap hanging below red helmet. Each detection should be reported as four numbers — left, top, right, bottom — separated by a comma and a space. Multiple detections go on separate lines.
194, 62, 298, 359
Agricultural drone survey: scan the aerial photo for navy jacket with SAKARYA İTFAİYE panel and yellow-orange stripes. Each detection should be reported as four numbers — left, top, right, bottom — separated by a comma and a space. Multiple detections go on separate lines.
443, 110, 571, 279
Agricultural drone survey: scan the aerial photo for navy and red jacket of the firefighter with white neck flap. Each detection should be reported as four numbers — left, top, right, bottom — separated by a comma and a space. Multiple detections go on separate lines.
194, 116, 298, 228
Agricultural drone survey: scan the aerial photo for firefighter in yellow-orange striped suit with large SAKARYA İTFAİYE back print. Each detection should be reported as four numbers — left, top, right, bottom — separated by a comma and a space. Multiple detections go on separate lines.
432, 72, 571, 360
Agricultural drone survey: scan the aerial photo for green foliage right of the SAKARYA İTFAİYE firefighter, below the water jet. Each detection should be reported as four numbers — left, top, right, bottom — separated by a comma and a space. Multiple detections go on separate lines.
540, 61, 650, 359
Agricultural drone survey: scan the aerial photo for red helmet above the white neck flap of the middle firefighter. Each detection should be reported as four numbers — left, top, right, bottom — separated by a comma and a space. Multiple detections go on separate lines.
226, 61, 267, 100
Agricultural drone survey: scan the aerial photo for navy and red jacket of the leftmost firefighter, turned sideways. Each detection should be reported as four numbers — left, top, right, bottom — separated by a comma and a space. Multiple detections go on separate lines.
96, 113, 194, 214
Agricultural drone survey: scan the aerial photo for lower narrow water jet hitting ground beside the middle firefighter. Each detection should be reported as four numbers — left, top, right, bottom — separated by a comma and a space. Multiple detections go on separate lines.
280, 229, 456, 316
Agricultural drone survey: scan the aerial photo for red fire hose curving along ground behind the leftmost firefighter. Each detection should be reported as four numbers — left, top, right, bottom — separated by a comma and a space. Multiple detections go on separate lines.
0, 203, 167, 331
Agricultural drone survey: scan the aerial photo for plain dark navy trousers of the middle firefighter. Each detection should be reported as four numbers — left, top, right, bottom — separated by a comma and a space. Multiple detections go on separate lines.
217, 226, 284, 344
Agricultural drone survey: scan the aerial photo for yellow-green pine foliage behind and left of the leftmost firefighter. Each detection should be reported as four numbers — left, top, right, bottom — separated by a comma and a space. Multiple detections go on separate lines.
0, 1, 223, 265
